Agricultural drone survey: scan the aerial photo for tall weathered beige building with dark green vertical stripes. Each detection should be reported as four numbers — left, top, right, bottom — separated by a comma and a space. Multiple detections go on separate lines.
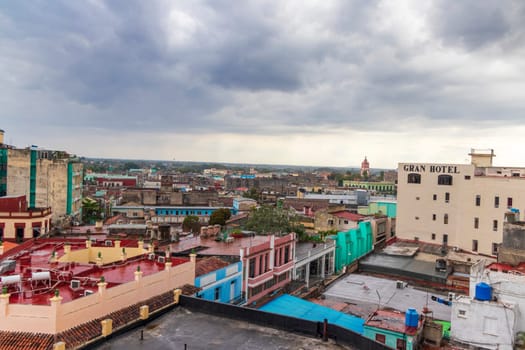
0, 132, 83, 221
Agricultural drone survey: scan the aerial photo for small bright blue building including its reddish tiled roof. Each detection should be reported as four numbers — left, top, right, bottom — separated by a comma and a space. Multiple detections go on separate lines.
195, 257, 242, 303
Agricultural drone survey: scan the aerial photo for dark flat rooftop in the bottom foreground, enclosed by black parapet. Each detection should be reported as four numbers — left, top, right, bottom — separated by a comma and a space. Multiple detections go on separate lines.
96, 307, 351, 350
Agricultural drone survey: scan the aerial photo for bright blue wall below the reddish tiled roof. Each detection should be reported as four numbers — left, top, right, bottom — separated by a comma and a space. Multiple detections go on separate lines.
195, 261, 242, 303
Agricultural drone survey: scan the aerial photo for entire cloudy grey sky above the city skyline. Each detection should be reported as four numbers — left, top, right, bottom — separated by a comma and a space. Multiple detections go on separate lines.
0, 0, 525, 168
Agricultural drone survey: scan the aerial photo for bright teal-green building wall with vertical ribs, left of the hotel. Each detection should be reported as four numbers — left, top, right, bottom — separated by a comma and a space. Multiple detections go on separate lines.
328, 221, 374, 272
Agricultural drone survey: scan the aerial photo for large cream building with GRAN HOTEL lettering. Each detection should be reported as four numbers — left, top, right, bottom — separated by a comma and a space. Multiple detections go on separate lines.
396, 150, 525, 255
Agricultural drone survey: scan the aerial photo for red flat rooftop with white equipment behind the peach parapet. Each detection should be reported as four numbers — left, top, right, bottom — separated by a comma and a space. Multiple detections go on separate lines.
0, 238, 189, 305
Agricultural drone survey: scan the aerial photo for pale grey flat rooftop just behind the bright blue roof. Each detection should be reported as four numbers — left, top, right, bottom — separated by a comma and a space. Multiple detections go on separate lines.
316, 274, 451, 321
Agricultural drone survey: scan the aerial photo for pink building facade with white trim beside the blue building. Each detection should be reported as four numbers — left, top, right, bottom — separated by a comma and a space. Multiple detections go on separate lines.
241, 233, 295, 304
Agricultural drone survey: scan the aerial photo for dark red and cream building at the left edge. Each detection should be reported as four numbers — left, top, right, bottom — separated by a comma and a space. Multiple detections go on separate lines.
0, 195, 51, 242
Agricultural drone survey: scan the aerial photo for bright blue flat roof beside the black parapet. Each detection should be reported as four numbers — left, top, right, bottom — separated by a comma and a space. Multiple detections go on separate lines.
260, 294, 365, 334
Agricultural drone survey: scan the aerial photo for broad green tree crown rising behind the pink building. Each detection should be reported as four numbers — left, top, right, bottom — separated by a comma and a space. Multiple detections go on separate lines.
244, 205, 304, 234
